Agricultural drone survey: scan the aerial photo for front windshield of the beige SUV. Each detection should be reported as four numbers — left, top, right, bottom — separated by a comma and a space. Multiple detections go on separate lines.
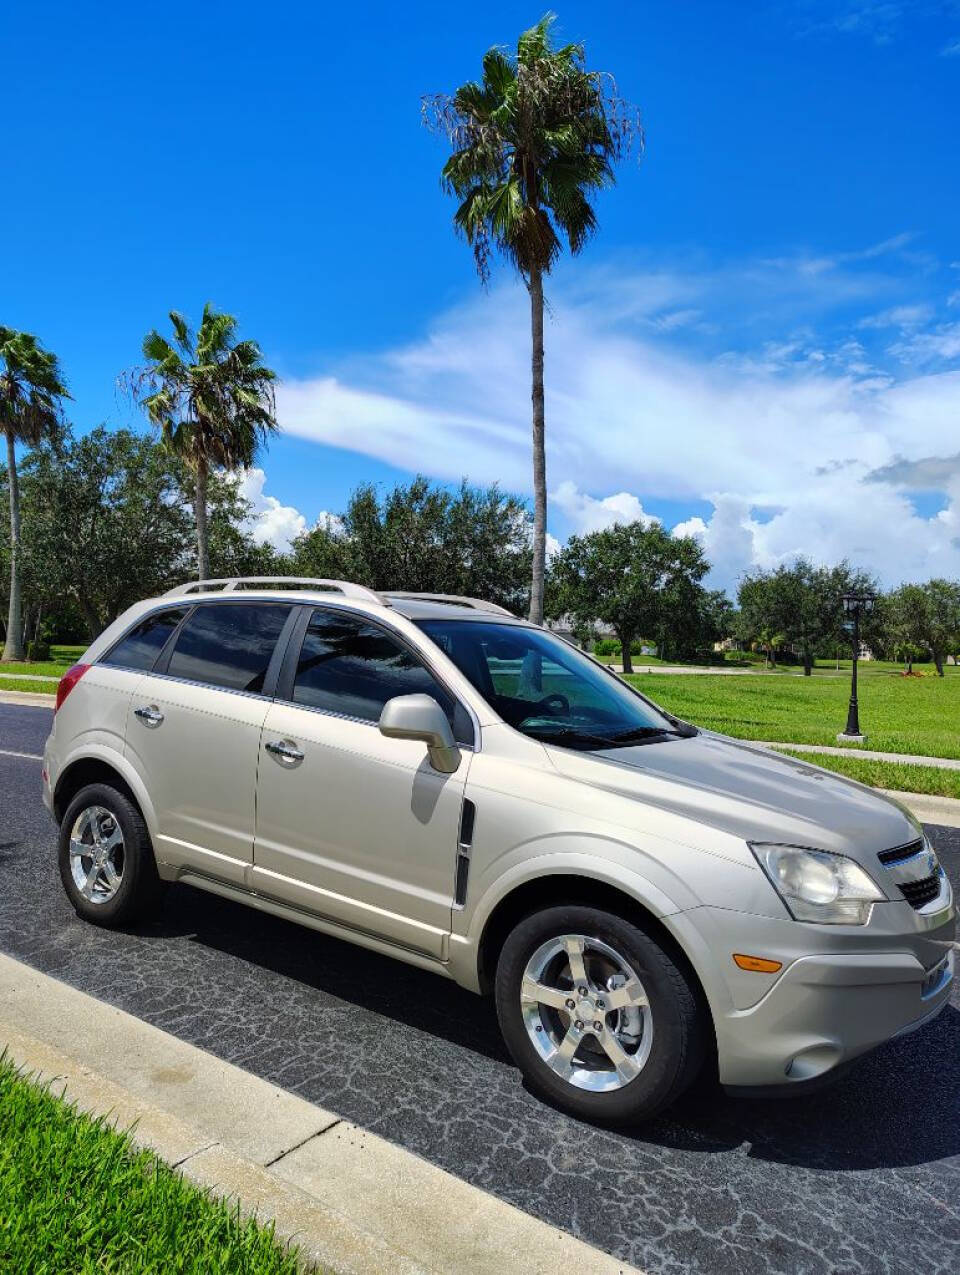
417, 620, 695, 750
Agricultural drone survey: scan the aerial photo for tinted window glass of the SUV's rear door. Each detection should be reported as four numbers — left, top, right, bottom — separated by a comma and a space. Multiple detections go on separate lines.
167, 602, 291, 694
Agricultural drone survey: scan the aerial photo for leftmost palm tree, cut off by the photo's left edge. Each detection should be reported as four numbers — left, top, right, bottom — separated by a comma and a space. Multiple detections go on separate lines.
0, 325, 70, 660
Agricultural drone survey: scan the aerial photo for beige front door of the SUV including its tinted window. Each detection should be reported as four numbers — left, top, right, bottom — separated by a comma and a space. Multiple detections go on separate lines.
251, 607, 473, 960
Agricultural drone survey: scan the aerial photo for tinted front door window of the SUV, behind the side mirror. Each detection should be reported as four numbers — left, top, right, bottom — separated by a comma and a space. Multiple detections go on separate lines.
292, 609, 473, 745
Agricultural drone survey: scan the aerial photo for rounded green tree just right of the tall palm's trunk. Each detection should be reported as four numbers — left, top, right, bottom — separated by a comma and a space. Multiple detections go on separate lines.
549, 523, 710, 673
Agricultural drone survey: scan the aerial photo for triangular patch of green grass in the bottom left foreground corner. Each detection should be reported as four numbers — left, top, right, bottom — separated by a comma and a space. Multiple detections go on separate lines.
0, 1057, 311, 1275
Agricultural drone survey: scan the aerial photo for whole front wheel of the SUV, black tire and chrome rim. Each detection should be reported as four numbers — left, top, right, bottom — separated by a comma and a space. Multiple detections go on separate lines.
496, 905, 708, 1125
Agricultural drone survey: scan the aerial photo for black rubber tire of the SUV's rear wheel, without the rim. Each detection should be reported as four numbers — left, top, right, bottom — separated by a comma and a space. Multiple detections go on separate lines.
57, 784, 164, 929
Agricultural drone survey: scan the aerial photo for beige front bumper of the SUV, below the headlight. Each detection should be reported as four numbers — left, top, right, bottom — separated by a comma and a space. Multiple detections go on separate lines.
686, 894, 960, 1091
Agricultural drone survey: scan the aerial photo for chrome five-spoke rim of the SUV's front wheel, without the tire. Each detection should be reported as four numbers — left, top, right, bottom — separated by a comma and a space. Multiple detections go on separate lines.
520, 935, 653, 1093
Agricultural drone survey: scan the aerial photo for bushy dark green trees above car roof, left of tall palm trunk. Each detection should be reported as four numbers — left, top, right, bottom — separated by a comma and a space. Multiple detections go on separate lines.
292, 476, 530, 611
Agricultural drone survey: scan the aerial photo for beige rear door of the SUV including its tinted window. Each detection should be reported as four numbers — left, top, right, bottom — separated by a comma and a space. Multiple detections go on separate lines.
125, 599, 293, 885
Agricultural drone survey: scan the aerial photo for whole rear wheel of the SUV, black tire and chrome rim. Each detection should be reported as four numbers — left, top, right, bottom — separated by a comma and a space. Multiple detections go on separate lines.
59, 784, 163, 927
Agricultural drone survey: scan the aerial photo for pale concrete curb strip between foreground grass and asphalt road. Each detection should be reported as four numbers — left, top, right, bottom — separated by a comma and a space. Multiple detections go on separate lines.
0, 955, 635, 1275
